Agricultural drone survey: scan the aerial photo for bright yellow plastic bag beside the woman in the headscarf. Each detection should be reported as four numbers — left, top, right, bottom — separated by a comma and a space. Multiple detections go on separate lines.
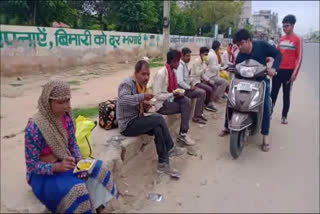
76, 115, 96, 159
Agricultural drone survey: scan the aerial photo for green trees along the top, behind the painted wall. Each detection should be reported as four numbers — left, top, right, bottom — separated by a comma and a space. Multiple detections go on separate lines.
0, 0, 242, 37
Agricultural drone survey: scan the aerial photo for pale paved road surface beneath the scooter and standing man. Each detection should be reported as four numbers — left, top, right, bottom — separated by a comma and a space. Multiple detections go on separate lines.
136, 44, 319, 213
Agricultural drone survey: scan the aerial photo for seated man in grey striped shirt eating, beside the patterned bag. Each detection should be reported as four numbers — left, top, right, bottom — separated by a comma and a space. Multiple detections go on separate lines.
117, 60, 185, 176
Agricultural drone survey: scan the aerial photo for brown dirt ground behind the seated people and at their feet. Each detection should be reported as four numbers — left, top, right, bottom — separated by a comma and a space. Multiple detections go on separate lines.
1, 54, 215, 212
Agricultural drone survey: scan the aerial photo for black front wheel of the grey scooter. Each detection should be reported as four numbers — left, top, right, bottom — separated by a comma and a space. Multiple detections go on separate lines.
230, 130, 245, 159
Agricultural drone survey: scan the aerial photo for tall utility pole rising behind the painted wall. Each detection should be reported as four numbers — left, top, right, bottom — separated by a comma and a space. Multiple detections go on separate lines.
162, 0, 170, 60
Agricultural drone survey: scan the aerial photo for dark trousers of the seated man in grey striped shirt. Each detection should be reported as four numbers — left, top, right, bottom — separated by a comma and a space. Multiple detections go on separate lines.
122, 114, 173, 163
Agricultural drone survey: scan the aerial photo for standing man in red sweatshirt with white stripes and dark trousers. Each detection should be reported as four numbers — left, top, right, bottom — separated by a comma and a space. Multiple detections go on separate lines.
271, 15, 303, 124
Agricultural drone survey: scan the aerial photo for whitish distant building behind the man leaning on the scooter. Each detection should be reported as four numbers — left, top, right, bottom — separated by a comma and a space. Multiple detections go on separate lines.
252, 10, 281, 41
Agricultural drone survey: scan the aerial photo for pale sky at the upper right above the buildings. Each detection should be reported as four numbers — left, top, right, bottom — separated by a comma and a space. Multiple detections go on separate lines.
252, 0, 320, 36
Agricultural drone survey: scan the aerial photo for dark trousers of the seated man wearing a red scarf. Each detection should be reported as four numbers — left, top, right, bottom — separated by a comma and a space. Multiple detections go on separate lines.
158, 96, 191, 133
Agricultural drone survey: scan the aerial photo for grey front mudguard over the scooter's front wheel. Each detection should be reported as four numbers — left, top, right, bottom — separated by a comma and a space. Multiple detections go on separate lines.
229, 111, 253, 131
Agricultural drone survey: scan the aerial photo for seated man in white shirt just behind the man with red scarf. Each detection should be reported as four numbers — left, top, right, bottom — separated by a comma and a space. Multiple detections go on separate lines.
176, 48, 207, 124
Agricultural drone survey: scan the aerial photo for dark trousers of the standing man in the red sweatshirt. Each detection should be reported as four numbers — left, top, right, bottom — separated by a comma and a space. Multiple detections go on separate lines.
271, 69, 293, 117
